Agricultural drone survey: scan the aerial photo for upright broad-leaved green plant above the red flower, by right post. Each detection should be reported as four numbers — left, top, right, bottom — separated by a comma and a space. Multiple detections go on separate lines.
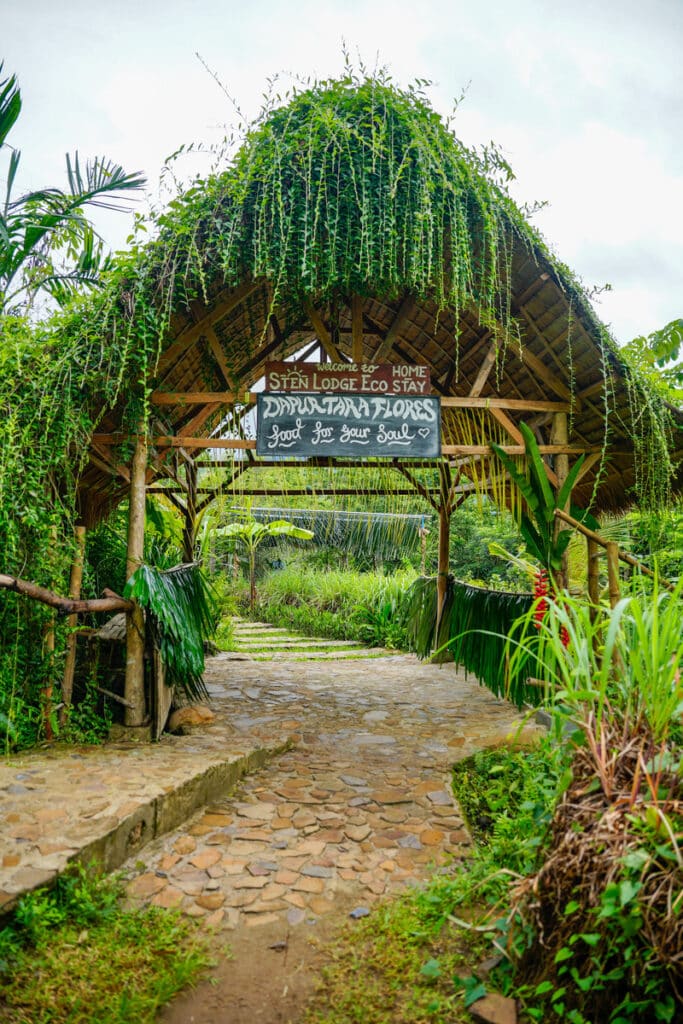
492, 423, 597, 578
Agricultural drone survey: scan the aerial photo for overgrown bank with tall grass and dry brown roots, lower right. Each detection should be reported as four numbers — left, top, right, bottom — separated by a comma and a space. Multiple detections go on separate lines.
505, 584, 683, 1024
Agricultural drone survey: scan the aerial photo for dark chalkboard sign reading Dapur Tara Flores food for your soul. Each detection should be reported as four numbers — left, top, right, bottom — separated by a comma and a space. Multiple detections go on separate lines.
256, 393, 441, 459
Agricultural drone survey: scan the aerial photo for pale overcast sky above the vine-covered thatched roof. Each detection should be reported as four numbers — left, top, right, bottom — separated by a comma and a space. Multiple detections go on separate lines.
0, 0, 683, 342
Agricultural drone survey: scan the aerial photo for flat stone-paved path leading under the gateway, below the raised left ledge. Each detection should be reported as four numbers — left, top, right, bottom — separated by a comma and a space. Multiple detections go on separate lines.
125, 655, 540, 929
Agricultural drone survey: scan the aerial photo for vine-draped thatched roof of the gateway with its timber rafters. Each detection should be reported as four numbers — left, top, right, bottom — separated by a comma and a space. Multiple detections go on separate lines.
69, 79, 683, 522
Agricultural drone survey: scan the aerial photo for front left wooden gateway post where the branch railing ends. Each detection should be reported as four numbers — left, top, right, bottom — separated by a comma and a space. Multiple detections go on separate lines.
124, 424, 147, 726
